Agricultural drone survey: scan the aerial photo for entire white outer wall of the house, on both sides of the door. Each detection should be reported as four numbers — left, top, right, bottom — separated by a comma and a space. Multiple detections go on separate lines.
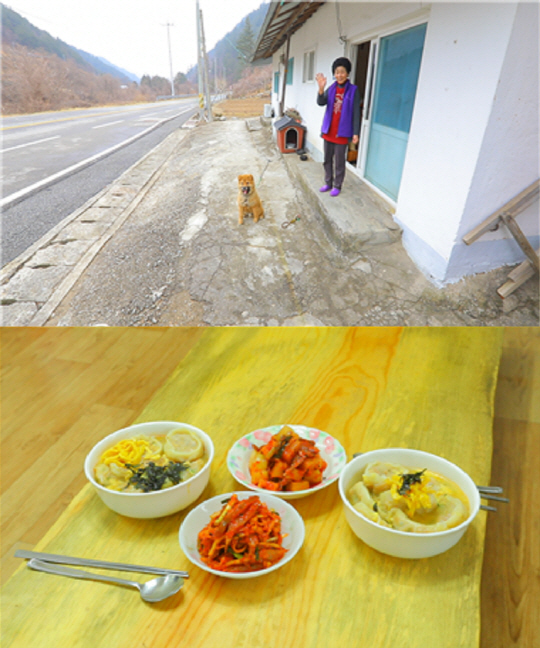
273, 2, 538, 283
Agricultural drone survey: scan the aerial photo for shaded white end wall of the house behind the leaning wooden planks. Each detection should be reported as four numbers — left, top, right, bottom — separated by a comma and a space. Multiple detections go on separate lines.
447, 3, 540, 278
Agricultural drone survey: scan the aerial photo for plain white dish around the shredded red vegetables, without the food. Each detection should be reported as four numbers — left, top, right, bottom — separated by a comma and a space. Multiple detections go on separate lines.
178, 491, 305, 579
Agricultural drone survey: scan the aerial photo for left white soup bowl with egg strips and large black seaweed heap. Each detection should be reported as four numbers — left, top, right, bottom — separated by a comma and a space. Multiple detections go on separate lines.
84, 421, 214, 518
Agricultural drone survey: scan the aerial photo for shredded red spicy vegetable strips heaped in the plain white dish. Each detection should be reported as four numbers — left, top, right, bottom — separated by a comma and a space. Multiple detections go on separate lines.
197, 494, 287, 572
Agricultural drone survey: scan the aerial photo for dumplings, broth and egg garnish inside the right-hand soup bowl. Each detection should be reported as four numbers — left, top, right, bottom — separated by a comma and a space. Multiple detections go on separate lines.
348, 461, 469, 533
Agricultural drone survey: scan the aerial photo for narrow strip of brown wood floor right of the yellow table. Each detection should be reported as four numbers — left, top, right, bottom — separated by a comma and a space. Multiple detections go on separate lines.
480, 328, 540, 648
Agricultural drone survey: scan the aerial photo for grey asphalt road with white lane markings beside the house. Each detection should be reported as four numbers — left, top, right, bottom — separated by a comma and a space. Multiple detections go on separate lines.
2, 100, 196, 265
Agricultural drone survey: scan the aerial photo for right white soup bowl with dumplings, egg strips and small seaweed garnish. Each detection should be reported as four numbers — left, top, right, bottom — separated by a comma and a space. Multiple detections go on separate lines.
339, 448, 480, 558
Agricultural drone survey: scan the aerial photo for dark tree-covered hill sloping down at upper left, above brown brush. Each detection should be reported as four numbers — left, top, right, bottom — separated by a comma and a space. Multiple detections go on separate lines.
0, 4, 138, 83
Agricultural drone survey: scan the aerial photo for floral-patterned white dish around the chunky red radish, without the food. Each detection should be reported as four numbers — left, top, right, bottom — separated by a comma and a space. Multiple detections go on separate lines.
227, 425, 347, 499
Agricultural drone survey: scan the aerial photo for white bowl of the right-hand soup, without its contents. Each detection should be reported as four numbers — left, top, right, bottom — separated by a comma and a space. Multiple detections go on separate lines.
339, 448, 480, 558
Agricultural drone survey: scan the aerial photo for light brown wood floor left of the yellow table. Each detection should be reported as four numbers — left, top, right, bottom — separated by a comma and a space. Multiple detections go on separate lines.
0, 327, 204, 583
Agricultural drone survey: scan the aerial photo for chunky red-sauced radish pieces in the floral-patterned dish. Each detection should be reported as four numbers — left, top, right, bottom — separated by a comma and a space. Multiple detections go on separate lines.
249, 425, 327, 491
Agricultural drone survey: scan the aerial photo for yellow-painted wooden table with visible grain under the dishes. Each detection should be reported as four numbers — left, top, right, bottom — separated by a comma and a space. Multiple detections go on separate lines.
1, 328, 502, 648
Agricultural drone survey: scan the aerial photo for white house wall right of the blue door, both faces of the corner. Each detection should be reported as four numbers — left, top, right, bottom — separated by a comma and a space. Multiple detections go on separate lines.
395, 3, 538, 282
